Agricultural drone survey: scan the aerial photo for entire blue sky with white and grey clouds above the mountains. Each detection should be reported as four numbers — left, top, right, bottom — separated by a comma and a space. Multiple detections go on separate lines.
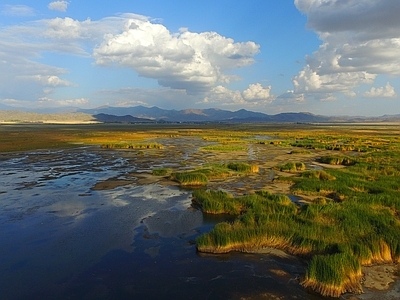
0, 0, 400, 116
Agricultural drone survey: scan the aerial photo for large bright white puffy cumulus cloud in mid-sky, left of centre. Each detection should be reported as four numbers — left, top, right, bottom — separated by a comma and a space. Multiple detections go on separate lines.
94, 15, 259, 94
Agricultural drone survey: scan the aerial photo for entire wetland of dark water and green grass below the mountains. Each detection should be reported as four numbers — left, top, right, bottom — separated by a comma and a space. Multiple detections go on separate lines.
0, 124, 400, 299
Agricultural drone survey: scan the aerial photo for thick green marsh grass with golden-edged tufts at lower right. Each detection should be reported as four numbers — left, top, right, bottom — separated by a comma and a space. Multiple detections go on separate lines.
193, 152, 400, 297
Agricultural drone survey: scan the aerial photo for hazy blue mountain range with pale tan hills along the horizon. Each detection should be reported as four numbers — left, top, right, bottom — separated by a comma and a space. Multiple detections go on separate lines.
0, 106, 400, 123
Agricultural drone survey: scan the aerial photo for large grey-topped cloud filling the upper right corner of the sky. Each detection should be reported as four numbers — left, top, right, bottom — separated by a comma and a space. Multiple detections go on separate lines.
293, 0, 400, 99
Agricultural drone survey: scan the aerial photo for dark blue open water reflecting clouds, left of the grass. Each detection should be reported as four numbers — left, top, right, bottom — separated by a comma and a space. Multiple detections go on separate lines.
0, 148, 396, 299
